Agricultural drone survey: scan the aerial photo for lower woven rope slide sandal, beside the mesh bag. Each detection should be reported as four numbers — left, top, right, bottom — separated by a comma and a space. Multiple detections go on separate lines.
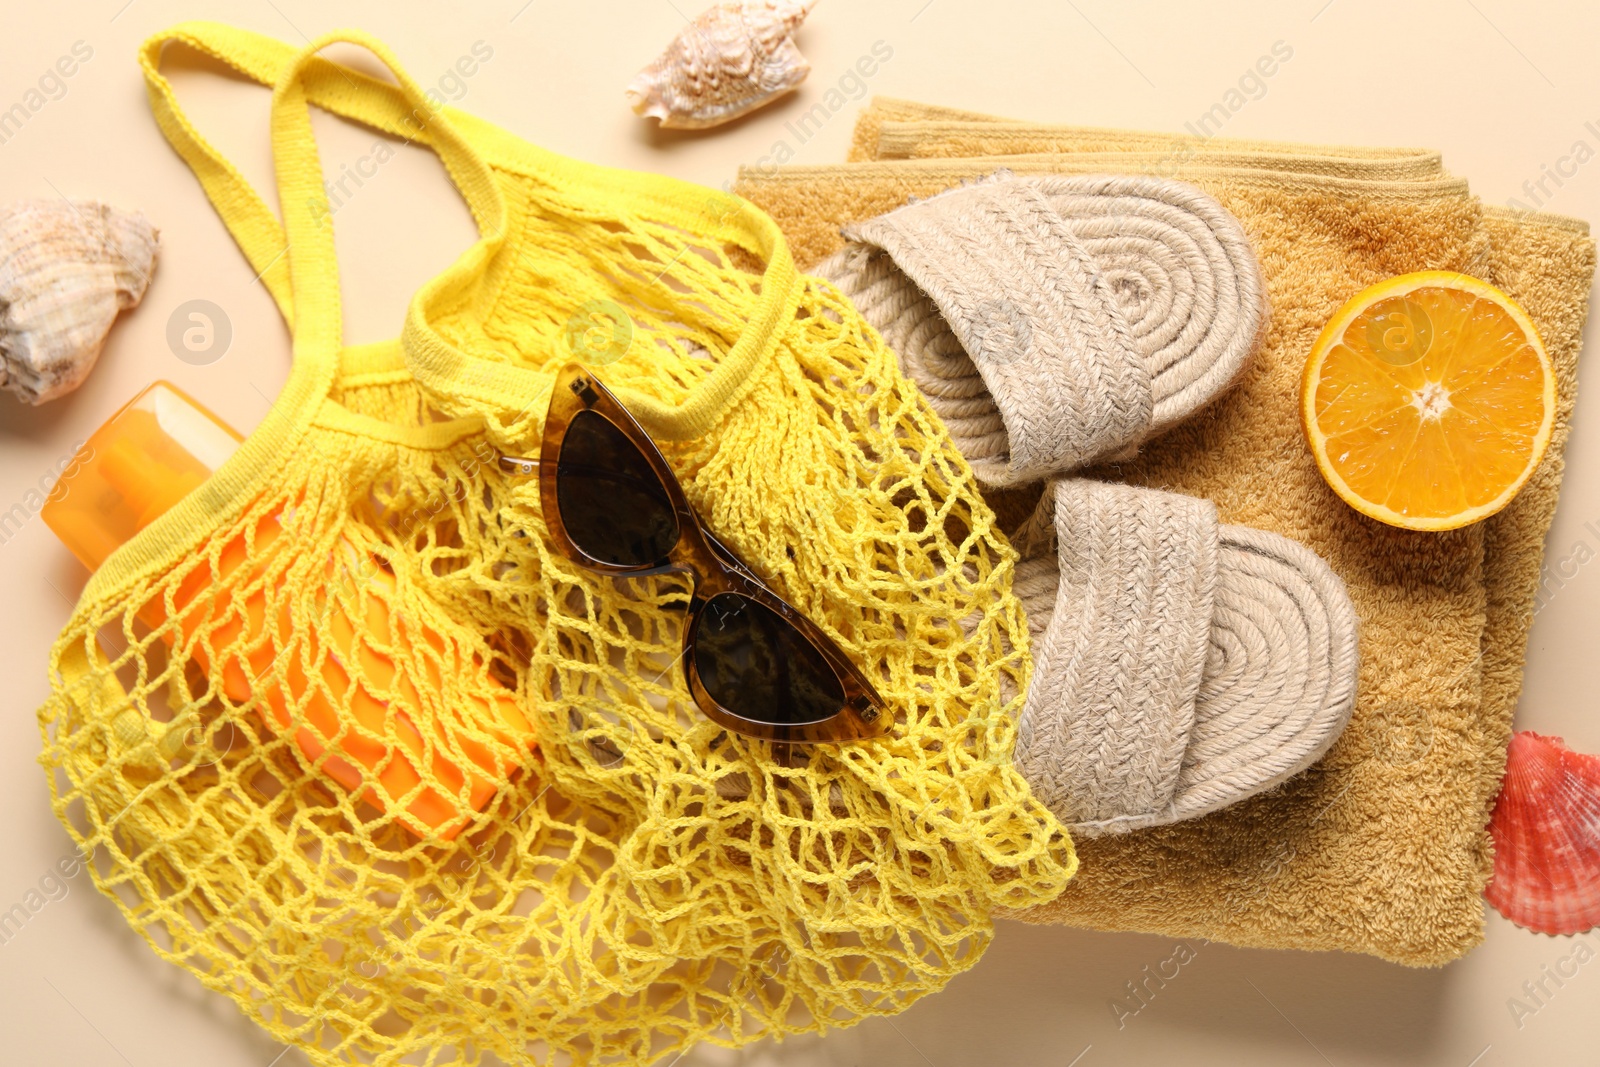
1014, 478, 1357, 837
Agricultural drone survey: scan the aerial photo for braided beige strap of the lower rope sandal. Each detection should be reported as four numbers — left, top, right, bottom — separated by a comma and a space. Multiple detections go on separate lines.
1014, 482, 1218, 825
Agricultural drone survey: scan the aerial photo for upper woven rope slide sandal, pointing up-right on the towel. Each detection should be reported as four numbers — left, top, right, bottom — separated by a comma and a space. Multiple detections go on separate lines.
814, 171, 1267, 485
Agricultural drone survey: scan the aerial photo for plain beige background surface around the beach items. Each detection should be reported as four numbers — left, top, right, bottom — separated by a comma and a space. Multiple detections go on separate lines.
0, 0, 1600, 1067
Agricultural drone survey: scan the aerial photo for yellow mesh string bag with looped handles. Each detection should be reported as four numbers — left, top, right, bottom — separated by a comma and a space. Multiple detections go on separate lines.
40, 24, 1075, 1064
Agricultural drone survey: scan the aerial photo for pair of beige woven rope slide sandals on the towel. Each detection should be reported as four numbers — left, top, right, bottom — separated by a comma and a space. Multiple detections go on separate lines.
816, 171, 1357, 835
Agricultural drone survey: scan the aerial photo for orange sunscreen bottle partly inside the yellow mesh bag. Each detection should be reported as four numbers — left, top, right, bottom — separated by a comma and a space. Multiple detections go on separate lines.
42, 382, 534, 840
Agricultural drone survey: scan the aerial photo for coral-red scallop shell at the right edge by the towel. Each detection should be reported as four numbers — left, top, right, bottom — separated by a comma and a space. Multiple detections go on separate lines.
1483, 731, 1600, 934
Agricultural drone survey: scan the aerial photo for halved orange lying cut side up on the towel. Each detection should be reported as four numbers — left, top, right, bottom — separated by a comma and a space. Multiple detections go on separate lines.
1301, 270, 1555, 530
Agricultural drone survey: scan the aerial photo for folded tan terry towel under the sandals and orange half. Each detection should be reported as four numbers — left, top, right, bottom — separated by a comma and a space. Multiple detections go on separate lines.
738, 102, 1594, 965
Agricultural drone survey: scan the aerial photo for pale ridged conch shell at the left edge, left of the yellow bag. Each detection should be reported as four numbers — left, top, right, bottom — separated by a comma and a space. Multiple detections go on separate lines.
0, 200, 157, 403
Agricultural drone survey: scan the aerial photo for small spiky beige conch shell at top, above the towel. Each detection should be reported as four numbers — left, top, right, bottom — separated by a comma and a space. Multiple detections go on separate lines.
627, 0, 816, 130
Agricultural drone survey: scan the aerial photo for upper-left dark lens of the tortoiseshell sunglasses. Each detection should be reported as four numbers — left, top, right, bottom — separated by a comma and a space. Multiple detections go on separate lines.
555, 411, 678, 566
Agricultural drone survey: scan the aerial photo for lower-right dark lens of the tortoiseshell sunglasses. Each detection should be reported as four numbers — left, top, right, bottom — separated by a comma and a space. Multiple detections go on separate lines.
694, 593, 845, 726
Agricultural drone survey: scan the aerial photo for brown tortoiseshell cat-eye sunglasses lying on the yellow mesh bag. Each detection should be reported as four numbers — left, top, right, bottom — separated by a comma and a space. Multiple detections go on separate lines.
499, 363, 890, 742
